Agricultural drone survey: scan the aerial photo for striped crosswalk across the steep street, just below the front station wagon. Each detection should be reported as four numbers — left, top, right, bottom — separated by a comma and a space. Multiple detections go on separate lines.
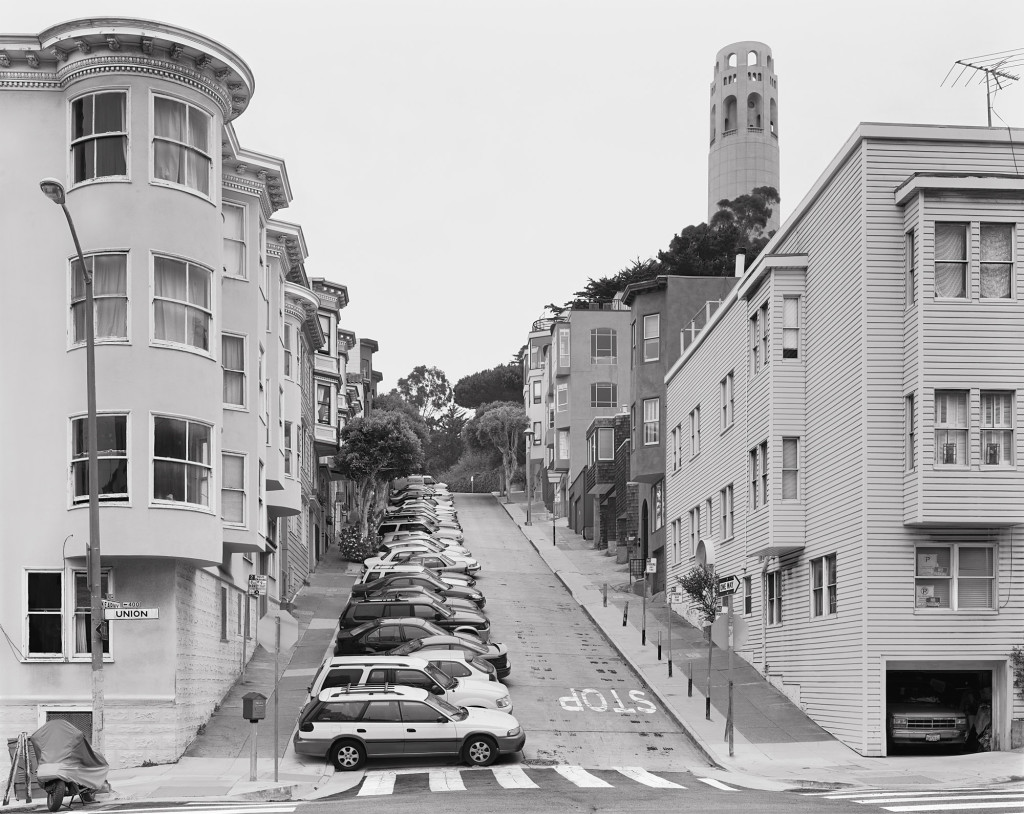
332, 765, 737, 798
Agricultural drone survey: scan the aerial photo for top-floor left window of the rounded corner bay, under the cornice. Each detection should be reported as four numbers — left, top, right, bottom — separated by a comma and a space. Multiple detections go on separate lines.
71, 90, 128, 183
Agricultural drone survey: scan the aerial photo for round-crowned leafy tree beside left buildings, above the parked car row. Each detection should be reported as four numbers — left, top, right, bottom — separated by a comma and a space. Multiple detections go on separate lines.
335, 410, 423, 540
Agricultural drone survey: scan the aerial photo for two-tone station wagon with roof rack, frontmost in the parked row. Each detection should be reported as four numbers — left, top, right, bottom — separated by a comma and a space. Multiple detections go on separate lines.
293, 686, 526, 771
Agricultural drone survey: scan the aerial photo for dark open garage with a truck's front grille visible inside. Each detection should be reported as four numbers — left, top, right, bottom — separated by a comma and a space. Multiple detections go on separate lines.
886, 669, 992, 755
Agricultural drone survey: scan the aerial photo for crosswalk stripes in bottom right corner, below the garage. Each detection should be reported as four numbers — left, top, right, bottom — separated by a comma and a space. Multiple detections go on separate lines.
798, 783, 1024, 814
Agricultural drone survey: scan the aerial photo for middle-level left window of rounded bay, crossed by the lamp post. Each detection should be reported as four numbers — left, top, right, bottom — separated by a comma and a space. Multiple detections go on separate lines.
71, 252, 128, 345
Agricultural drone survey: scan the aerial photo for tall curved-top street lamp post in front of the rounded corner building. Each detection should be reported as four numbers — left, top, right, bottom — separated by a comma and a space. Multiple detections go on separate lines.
39, 178, 104, 752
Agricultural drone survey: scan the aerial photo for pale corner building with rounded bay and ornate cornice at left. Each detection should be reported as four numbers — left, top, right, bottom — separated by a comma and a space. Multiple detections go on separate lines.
0, 17, 335, 767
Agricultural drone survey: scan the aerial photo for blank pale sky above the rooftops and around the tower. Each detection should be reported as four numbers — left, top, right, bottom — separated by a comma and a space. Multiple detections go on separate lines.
8, 0, 1024, 389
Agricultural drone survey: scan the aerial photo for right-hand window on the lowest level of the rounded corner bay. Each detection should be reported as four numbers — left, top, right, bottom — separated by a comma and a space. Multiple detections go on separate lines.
153, 416, 212, 507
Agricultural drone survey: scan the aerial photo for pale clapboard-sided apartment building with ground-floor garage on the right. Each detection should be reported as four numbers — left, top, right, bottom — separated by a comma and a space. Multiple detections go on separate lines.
665, 124, 1024, 756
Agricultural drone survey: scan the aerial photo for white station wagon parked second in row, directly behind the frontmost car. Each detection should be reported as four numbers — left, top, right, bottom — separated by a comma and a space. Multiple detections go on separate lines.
308, 654, 512, 713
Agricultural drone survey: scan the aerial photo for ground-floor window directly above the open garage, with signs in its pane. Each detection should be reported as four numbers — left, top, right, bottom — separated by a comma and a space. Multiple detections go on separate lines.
914, 544, 995, 610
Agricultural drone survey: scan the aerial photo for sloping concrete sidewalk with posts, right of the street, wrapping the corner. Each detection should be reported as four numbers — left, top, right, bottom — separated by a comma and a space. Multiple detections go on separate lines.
496, 492, 1024, 788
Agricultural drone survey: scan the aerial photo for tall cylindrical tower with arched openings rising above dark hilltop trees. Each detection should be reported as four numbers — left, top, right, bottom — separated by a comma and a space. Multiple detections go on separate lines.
708, 41, 781, 231
